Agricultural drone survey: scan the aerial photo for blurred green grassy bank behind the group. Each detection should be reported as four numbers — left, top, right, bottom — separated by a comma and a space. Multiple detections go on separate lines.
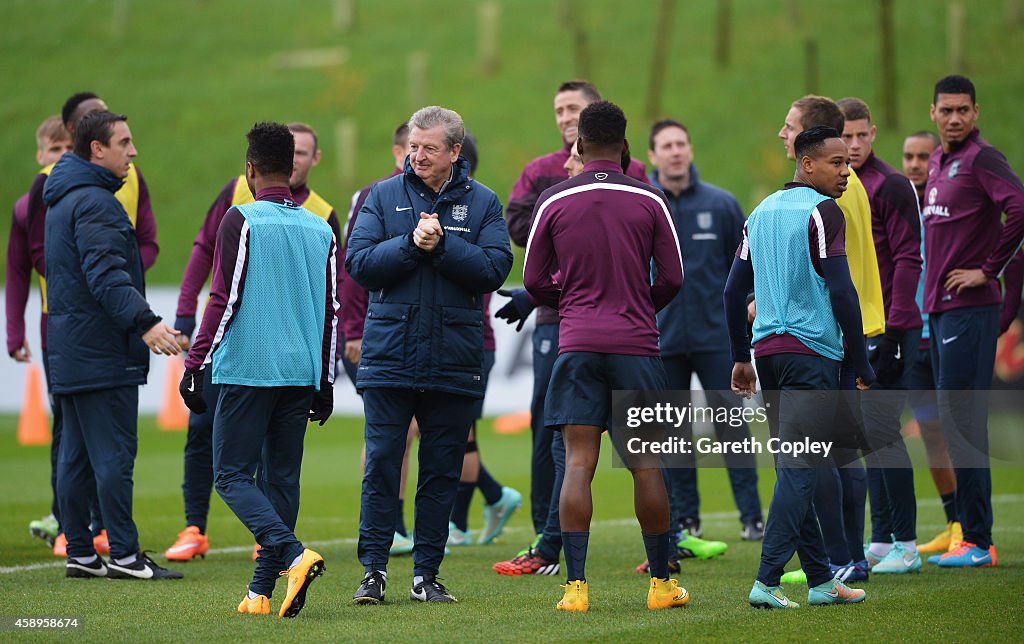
0, 0, 1024, 284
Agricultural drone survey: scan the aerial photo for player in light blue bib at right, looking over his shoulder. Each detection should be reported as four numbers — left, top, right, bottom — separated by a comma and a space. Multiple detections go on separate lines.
724, 127, 874, 608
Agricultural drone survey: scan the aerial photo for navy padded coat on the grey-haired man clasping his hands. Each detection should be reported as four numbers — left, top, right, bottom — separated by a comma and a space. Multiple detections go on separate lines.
345, 158, 512, 398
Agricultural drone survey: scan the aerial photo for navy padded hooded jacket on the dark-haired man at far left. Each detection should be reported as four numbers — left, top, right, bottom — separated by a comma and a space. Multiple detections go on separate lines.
43, 154, 160, 394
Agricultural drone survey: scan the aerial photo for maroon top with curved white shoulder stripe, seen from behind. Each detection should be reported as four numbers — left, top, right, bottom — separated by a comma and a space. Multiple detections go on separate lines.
523, 161, 683, 356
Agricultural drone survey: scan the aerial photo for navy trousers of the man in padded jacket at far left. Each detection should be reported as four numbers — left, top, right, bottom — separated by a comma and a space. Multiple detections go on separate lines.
55, 385, 139, 559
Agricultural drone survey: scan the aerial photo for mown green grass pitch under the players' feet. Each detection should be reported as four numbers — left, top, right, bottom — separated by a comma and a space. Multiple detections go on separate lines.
0, 417, 1024, 642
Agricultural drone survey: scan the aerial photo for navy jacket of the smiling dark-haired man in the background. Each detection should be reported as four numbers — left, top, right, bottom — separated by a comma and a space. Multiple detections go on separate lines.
650, 166, 745, 357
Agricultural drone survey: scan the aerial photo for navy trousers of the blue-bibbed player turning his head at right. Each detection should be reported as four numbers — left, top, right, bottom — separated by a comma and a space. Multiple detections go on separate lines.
757, 353, 840, 587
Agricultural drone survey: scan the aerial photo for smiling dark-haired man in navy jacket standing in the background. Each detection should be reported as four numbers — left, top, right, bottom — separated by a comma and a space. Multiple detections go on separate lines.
638, 119, 764, 571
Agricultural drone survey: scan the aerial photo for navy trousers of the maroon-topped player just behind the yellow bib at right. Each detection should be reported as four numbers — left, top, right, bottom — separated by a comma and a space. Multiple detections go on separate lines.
860, 330, 921, 544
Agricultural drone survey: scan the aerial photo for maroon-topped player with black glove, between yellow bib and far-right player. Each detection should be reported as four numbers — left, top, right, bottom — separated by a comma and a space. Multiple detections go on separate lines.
838, 96, 922, 573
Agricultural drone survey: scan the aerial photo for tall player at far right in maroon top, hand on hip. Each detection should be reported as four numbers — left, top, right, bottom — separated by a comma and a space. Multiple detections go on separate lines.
923, 76, 1024, 567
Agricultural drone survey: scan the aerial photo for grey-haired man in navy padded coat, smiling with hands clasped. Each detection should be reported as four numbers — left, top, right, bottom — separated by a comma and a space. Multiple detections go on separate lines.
345, 106, 512, 604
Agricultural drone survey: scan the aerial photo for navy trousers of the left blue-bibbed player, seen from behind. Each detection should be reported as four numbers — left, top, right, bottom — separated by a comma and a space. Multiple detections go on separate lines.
213, 385, 313, 597
